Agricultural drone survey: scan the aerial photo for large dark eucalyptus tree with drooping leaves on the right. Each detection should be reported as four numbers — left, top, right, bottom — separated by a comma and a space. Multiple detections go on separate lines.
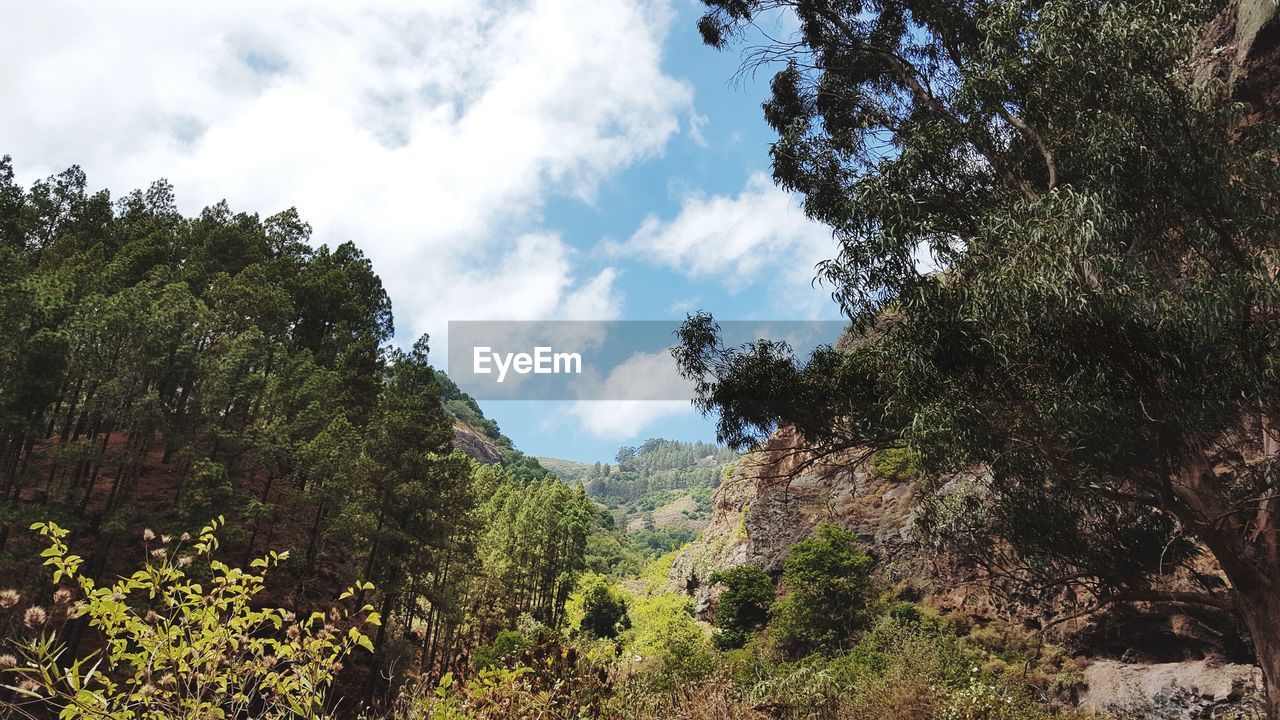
677, 0, 1280, 717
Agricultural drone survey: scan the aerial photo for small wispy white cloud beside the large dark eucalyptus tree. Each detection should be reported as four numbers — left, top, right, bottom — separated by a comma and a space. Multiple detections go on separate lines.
605, 172, 835, 307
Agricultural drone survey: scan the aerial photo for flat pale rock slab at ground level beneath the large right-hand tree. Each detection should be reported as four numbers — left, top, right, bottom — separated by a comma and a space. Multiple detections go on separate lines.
1080, 660, 1266, 720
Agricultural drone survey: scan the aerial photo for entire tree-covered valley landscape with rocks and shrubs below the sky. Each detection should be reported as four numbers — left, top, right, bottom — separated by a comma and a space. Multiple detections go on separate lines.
0, 0, 1280, 720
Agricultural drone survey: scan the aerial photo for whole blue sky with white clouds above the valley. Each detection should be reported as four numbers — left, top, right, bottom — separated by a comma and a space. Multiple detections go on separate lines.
0, 0, 838, 461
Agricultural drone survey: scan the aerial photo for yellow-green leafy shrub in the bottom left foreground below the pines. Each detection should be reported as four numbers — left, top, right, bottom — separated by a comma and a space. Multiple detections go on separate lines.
4, 518, 380, 720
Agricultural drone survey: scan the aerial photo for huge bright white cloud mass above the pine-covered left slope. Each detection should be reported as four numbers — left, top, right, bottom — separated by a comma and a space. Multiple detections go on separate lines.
0, 0, 692, 338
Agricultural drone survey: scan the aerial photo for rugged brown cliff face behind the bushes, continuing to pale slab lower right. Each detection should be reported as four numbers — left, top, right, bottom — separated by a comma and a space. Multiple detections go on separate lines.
668, 430, 1262, 719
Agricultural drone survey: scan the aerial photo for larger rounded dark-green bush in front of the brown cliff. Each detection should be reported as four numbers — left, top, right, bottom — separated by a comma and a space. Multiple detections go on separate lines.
769, 523, 874, 656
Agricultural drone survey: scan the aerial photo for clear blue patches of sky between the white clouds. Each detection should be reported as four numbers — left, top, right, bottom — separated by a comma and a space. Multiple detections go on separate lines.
481, 3, 838, 461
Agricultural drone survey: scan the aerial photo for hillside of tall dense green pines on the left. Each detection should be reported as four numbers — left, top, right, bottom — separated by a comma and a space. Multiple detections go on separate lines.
0, 158, 599, 693
